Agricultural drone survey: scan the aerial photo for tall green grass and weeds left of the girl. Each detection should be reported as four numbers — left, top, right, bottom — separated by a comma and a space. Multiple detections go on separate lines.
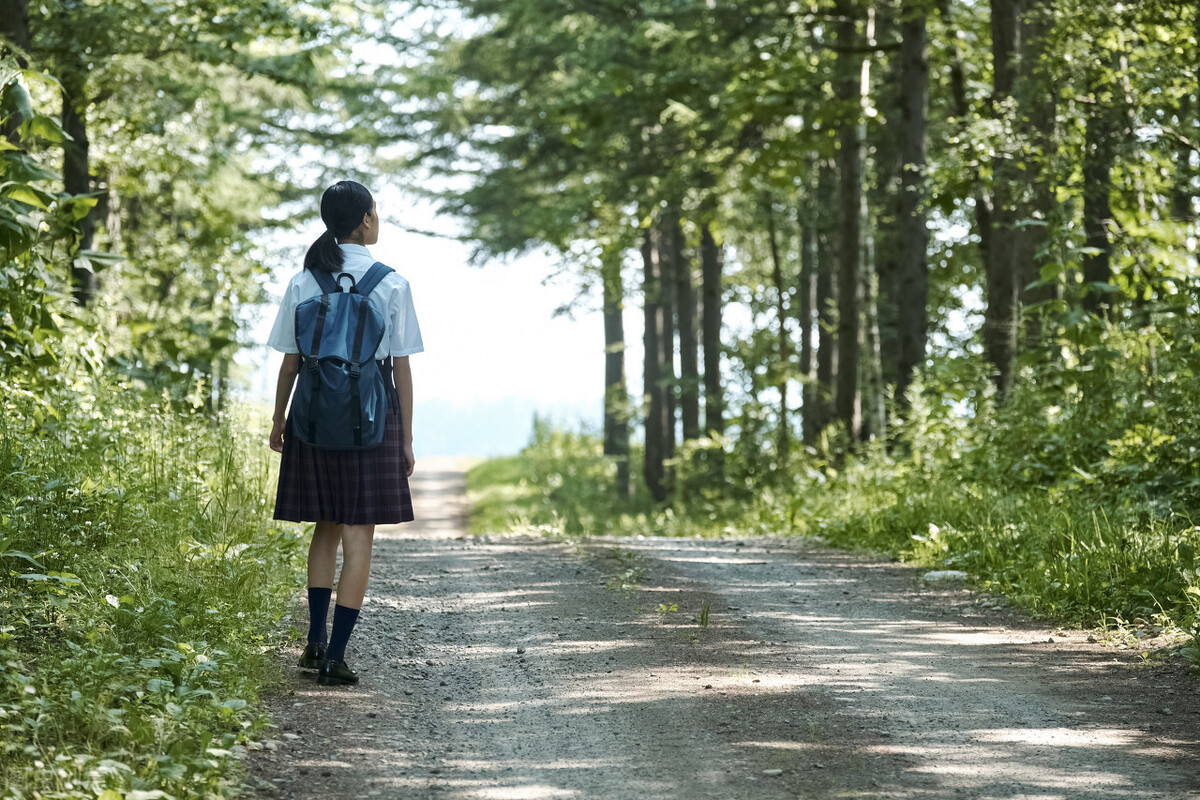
0, 384, 302, 800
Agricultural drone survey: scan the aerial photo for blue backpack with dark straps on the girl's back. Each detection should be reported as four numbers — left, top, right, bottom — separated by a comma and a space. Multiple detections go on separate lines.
292, 261, 392, 450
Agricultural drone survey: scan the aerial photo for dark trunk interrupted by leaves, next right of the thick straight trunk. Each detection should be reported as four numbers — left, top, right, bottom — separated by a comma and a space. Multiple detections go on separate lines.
983, 0, 1021, 396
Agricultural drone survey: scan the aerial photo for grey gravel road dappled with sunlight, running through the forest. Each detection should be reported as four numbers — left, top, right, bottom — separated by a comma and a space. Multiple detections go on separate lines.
248, 462, 1200, 800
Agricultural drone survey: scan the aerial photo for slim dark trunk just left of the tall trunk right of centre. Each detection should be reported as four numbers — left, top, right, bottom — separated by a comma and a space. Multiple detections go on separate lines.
814, 162, 838, 433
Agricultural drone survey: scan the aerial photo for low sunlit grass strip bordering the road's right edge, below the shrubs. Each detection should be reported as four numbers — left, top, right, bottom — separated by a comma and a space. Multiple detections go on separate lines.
467, 431, 1200, 662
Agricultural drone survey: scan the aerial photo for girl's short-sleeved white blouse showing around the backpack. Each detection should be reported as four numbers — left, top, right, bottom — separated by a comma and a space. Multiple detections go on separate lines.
266, 245, 425, 361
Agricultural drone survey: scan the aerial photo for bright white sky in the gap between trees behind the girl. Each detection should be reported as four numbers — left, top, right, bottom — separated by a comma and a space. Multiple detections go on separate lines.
240, 186, 642, 458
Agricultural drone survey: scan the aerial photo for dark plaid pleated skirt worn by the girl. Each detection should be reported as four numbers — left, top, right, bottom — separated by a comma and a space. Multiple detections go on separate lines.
275, 369, 413, 525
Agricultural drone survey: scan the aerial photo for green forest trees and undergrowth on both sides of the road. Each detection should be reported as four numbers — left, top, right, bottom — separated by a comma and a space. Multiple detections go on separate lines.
0, 0, 1200, 800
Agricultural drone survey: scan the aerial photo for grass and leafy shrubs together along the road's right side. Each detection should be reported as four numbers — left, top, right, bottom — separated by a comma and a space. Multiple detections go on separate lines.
468, 354, 1200, 662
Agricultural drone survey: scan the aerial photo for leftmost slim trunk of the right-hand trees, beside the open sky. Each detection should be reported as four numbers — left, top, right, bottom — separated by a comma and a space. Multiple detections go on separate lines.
600, 247, 629, 500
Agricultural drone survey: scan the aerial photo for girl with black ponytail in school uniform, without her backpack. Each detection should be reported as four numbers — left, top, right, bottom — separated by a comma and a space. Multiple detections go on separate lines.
268, 181, 425, 686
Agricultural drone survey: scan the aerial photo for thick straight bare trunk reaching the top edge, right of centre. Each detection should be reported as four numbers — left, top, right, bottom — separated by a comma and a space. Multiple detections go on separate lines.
895, 7, 929, 408
